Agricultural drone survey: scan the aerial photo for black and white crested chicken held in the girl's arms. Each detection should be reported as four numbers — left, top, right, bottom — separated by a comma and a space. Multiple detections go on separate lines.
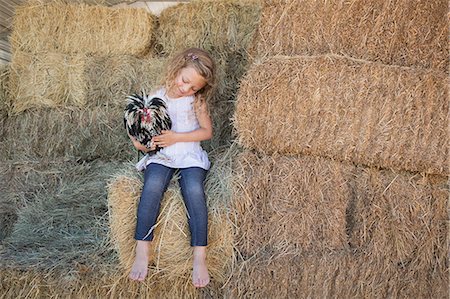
124, 91, 172, 155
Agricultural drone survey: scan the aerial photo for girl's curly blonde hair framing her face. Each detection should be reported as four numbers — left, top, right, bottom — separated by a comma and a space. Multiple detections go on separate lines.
162, 48, 216, 109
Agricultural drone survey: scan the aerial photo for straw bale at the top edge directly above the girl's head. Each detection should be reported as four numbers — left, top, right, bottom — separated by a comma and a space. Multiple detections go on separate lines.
156, 0, 260, 58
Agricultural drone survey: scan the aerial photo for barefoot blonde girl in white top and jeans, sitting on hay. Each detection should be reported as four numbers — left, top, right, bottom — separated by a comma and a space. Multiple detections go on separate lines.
129, 48, 215, 287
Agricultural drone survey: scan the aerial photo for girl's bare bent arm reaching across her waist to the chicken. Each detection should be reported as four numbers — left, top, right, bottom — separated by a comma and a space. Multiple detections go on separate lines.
153, 103, 212, 147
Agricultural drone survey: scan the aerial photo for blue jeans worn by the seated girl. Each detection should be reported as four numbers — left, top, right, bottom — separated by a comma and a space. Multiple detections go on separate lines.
135, 163, 208, 246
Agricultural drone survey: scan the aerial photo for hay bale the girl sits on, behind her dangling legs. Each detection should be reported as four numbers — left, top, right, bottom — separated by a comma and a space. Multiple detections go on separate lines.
108, 148, 237, 295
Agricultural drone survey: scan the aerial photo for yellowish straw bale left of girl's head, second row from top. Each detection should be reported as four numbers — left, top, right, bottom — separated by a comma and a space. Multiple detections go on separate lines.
10, 52, 165, 114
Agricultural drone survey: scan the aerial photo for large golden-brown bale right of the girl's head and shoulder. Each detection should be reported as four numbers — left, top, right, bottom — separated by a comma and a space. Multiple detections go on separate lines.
234, 55, 449, 175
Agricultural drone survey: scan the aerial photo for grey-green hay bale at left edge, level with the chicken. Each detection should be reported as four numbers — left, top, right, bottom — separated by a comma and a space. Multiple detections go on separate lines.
0, 107, 137, 161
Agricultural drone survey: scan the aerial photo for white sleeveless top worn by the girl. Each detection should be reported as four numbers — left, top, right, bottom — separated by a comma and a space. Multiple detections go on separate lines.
136, 88, 211, 171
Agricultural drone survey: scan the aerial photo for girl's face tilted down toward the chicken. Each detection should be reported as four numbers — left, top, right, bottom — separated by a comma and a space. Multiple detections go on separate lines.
169, 66, 206, 98
